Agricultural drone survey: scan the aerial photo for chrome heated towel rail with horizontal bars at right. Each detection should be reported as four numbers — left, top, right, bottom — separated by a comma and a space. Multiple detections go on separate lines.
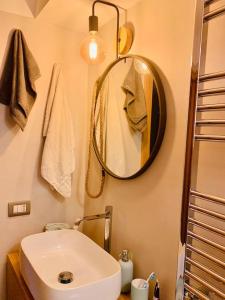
181, 0, 225, 300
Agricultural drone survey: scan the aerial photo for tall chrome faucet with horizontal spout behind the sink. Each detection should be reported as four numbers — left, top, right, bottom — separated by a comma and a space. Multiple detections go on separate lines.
75, 206, 113, 253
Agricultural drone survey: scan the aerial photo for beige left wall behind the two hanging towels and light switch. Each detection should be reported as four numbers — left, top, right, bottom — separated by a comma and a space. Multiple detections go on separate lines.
0, 12, 87, 300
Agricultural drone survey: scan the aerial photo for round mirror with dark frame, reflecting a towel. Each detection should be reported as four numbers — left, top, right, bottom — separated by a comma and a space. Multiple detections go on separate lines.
93, 55, 166, 179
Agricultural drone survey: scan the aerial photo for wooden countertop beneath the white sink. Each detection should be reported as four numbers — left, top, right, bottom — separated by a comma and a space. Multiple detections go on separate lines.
7, 252, 130, 300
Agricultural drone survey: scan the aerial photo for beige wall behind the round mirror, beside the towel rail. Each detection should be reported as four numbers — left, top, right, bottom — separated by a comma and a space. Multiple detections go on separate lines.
85, 0, 195, 300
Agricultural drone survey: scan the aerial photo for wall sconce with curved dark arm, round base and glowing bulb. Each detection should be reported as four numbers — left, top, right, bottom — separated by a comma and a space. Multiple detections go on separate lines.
81, 0, 133, 64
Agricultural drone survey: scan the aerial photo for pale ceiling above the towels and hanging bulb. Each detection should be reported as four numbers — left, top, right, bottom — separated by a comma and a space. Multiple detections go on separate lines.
0, 0, 141, 32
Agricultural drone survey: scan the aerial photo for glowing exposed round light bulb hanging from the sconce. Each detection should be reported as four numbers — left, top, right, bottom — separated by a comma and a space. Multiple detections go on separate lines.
81, 31, 105, 64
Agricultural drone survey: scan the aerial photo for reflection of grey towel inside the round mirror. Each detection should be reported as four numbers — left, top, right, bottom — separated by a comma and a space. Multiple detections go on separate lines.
122, 62, 147, 132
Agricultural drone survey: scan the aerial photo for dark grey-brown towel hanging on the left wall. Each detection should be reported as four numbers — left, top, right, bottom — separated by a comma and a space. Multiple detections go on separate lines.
0, 30, 41, 130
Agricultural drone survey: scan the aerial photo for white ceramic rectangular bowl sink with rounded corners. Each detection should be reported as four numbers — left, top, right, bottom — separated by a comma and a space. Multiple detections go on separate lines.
20, 230, 121, 300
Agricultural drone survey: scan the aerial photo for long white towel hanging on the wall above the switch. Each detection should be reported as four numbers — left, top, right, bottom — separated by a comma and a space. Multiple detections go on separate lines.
41, 64, 75, 198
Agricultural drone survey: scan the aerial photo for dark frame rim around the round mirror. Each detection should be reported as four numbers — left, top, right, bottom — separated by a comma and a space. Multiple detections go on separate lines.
93, 55, 167, 180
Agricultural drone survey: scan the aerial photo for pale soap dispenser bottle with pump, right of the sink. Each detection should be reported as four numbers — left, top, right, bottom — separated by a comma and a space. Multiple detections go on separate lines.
119, 250, 133, 293
